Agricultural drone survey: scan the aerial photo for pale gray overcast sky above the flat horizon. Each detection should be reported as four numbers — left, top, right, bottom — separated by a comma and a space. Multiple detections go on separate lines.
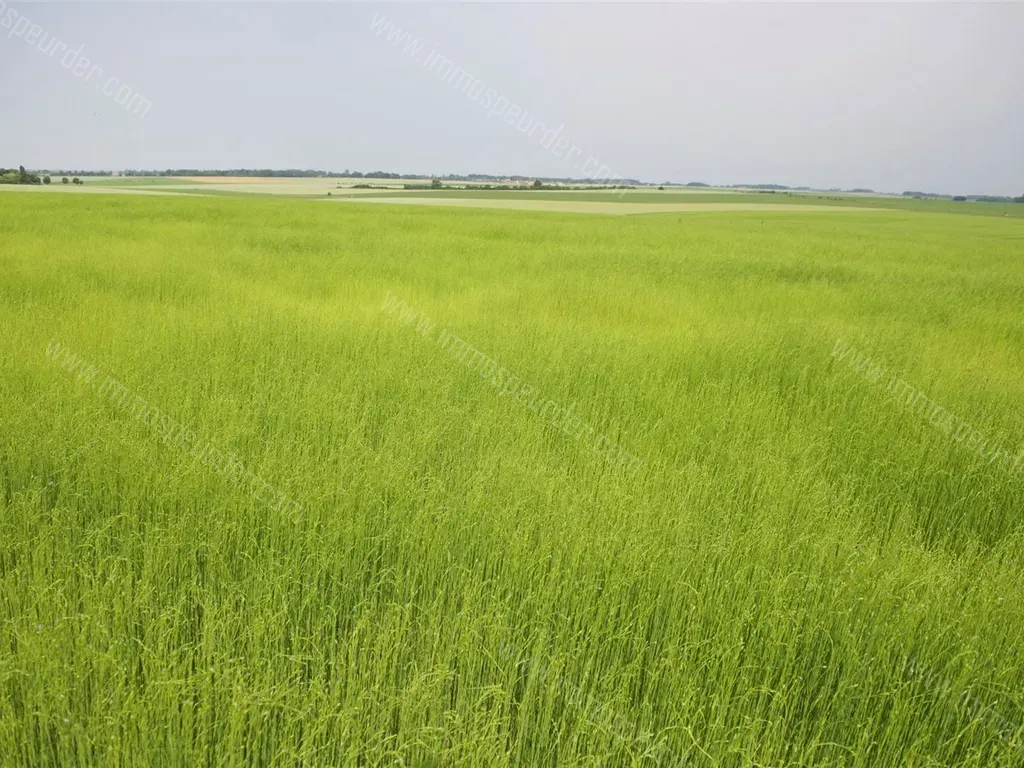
0, 0, 1024, 195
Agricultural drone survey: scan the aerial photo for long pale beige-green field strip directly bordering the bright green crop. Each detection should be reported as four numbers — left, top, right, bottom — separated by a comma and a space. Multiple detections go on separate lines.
325, 197, 882, 216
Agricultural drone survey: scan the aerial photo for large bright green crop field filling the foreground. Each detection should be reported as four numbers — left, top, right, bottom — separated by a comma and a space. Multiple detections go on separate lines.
0, 184, 1024, 768
